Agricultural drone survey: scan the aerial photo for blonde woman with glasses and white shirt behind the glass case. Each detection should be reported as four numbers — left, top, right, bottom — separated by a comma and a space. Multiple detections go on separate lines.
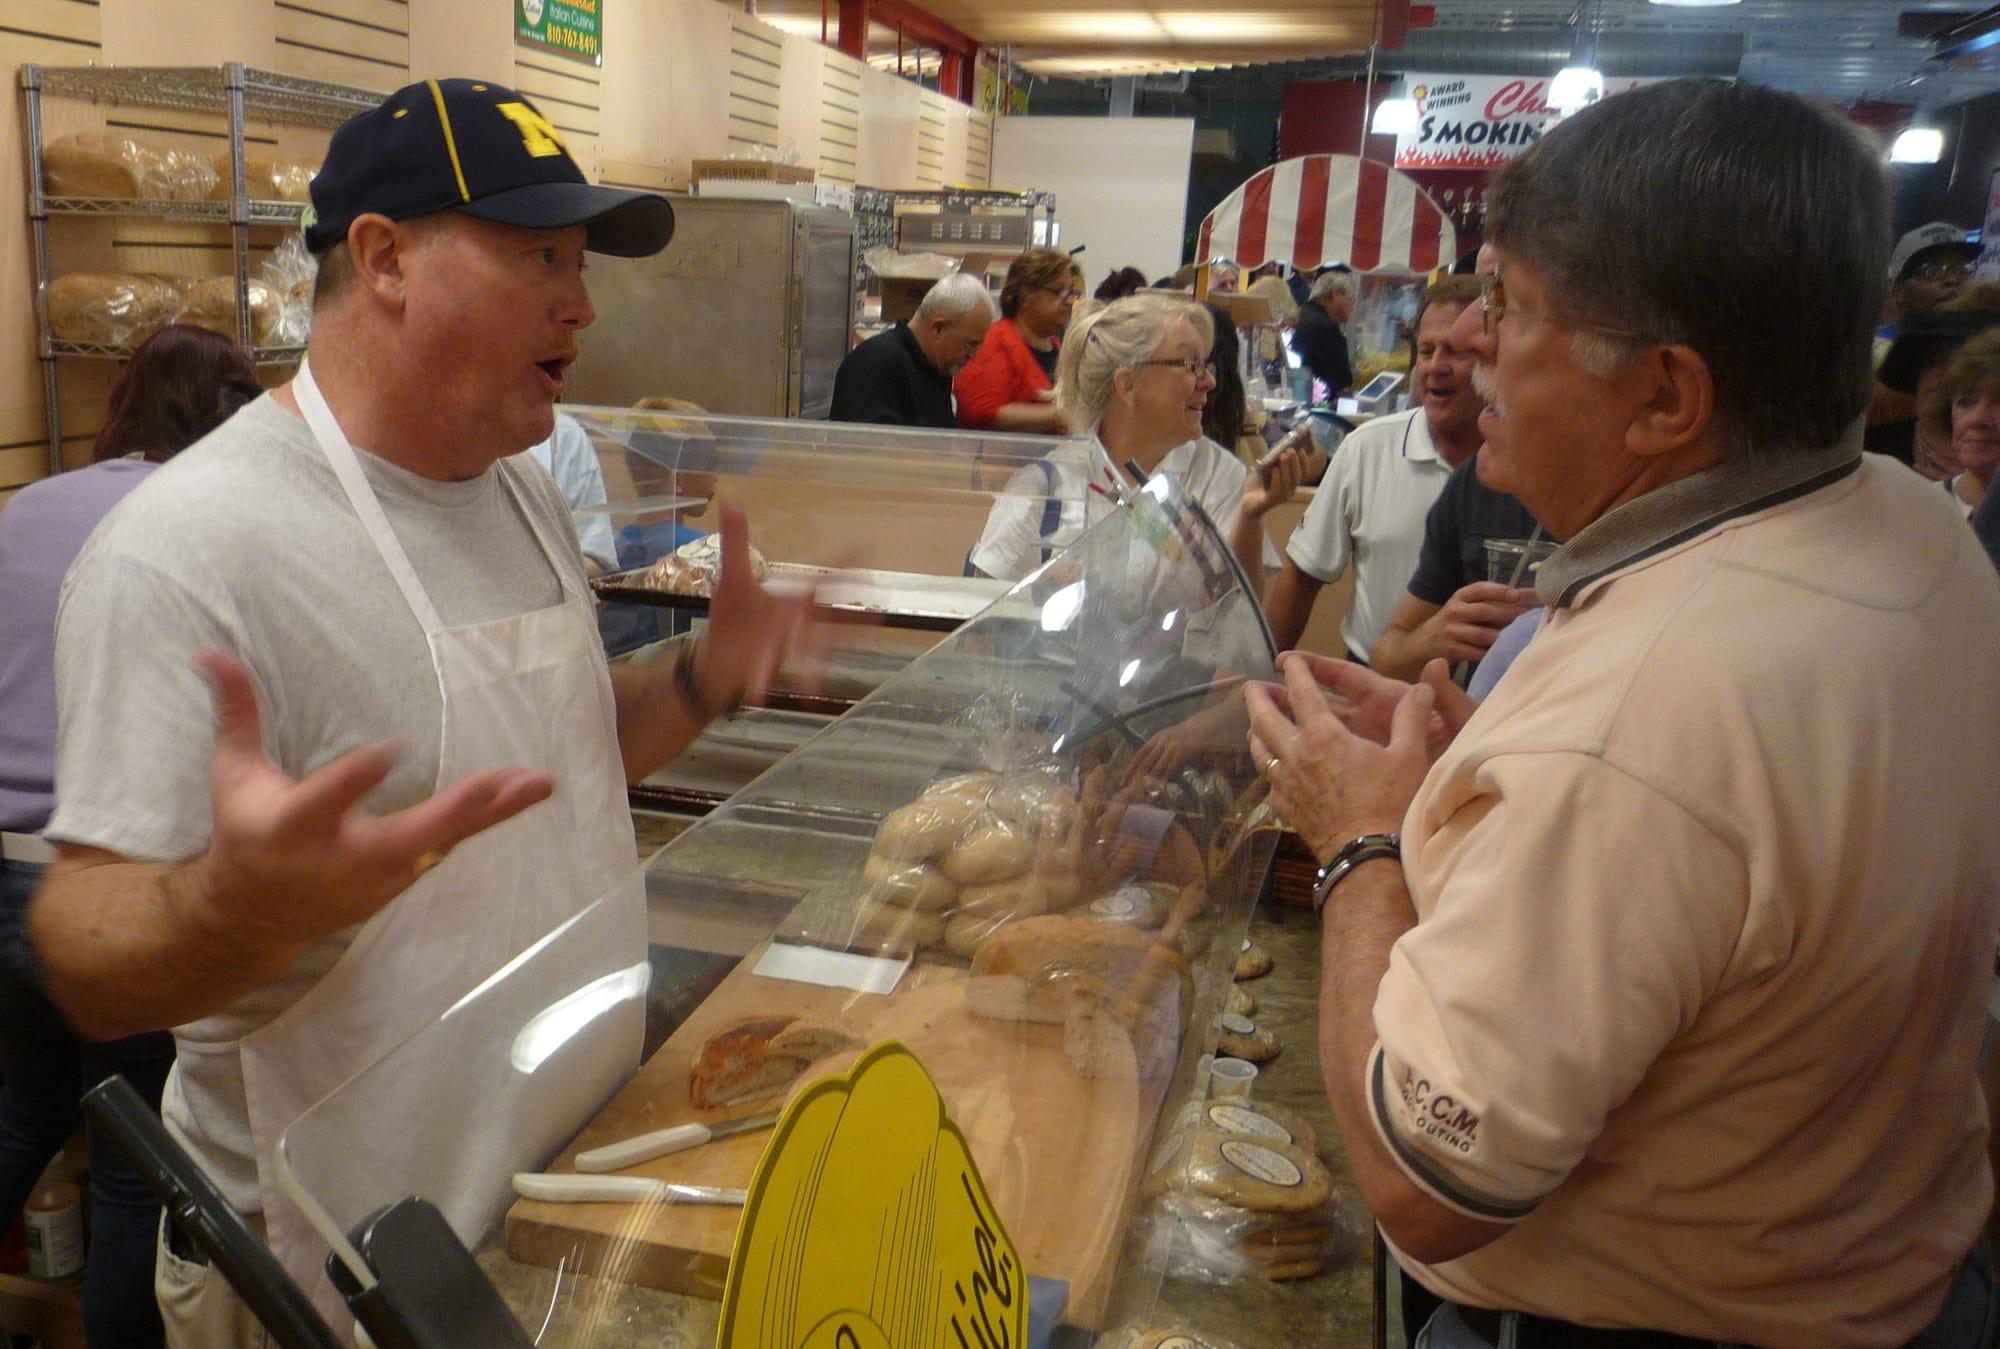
972, 294, 1304, 580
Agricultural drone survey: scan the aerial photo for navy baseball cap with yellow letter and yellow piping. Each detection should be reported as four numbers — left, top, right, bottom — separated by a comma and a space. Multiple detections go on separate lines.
304, 80, 674, 258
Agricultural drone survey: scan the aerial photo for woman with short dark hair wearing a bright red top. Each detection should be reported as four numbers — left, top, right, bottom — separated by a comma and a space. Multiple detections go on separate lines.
952, 248, 1082, 434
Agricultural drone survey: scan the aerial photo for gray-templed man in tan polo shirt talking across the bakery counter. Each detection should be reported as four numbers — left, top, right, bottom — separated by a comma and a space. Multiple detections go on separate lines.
1246, 80, 2000, 1349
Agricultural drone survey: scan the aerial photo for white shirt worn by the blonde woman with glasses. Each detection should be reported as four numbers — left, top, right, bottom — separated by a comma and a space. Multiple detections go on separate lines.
972, 436, 1282, 580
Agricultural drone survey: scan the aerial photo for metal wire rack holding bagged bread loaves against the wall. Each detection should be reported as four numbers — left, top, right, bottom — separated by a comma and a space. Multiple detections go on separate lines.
20, 62, 382, 472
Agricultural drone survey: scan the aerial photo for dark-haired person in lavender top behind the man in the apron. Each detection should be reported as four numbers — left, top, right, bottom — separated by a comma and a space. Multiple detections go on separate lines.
0, 324, 262, 1349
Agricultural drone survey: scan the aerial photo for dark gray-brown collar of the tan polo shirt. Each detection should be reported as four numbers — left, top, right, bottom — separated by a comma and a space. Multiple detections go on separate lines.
1534, 422, 1862, 608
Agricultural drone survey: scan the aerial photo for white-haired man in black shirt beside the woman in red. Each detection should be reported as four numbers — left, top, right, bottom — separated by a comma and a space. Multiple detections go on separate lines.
828, 272, 996, 428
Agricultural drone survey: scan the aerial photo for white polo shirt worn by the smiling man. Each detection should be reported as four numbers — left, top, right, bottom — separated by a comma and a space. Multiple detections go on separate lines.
1284, 408, 1452, 660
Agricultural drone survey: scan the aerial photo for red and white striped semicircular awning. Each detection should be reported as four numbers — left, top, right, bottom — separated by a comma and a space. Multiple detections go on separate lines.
1198, 154, 1458, 272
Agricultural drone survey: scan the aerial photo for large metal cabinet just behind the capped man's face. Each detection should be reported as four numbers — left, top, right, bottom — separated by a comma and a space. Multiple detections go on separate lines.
570, 196, 856, 418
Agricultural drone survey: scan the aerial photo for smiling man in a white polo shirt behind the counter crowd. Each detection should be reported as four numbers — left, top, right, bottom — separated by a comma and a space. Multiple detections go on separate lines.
1266, 276, 1486, 662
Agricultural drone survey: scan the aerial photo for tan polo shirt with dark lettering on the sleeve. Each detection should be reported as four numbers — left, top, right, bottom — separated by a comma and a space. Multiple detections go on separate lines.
1372, 446, 2000, 1349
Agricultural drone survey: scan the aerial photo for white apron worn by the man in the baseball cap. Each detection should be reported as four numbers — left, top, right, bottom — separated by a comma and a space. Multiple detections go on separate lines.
242, 364, 646, 1325
